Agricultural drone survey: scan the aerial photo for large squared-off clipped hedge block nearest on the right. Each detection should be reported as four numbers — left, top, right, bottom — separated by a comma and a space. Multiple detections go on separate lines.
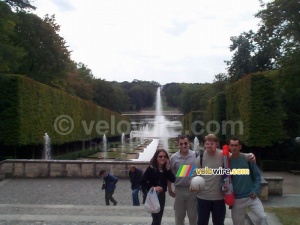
226, 72, 285, 147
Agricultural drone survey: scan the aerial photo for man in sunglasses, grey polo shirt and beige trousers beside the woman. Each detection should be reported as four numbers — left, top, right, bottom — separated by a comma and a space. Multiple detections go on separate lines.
168, 135, 198, 225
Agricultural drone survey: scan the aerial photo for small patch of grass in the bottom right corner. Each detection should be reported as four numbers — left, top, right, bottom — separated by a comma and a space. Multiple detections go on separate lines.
265, 207, 300, 225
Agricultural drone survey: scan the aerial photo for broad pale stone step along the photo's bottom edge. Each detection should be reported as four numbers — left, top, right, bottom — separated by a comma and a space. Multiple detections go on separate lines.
0, 204, 236, 225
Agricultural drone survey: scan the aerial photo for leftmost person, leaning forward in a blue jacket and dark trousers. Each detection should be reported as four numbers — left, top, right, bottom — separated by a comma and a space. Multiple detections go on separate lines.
100, 170, 118, 205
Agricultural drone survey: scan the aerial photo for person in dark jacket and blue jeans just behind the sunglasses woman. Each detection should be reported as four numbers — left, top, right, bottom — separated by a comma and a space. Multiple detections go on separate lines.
129, 166, 143, 206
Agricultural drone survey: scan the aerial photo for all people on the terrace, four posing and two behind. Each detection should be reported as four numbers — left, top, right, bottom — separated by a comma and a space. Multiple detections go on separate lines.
100, 134, 267, 225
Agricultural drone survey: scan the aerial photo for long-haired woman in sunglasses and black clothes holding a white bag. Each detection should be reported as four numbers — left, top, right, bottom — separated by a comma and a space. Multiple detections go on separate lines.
141, 149, 176, 225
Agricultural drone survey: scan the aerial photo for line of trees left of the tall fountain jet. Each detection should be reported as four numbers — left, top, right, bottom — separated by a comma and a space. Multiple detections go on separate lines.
0, 0, 160, 112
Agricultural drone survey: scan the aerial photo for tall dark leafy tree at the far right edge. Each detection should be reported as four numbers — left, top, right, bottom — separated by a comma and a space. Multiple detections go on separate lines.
256, 0, 300, 137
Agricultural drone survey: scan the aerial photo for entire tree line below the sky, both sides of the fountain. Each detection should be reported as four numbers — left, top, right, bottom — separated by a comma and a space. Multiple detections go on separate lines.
0, 0, 300, 141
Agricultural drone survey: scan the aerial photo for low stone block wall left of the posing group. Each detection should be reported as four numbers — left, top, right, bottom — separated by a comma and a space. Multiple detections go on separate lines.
0, 159, 149, 179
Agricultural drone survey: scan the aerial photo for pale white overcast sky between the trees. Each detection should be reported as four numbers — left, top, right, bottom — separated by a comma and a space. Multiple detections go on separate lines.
33, 0, 268, 85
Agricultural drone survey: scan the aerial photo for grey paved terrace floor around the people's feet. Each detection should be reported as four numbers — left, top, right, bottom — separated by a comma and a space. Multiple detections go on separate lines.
0, 173, 300, 225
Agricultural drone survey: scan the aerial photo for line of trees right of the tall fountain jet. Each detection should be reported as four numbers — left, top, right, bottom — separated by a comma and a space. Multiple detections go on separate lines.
164, 0, 300, 141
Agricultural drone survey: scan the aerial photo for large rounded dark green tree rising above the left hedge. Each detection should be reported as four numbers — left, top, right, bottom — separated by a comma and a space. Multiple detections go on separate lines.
14, 12, 70, 88
